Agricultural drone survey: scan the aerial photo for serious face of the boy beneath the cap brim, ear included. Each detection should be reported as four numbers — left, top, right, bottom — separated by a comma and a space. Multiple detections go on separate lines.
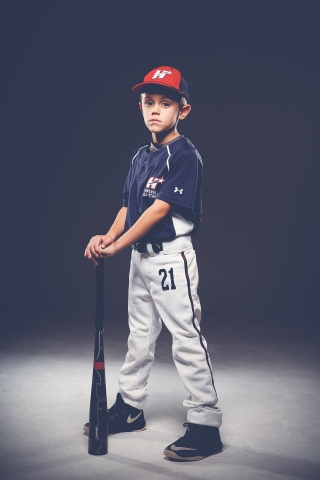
139, 93, 191, 134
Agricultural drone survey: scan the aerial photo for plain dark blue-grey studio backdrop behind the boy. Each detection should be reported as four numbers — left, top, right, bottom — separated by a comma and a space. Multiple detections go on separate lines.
1, 0, 320, 334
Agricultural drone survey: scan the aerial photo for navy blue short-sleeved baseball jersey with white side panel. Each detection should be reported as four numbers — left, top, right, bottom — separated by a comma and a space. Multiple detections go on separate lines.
122, 136, 203, 243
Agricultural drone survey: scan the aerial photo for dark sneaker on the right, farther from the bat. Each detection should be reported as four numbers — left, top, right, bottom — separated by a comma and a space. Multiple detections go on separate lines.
163, 423, 222, 461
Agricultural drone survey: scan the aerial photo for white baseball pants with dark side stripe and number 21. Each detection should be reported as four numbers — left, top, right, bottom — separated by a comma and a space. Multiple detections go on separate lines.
119, 237, 222, 427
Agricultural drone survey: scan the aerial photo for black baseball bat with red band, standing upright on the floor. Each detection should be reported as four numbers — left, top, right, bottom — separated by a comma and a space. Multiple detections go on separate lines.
88, 259, 108, 455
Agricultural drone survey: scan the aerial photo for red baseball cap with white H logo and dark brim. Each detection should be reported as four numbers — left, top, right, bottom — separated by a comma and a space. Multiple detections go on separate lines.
132, 66, 189, 101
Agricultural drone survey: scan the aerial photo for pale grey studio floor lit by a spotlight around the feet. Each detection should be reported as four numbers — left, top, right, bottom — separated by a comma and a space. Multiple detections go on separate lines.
0, 316, 320, 480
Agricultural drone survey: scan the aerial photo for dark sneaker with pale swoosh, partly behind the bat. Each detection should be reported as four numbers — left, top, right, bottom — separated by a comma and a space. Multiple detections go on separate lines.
83, 393, 147, 435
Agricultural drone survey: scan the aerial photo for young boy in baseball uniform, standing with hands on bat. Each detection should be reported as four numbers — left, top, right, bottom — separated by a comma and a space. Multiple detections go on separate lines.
84, 66, 222, 460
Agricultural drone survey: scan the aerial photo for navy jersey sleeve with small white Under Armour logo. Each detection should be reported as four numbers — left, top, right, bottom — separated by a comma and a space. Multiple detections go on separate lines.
157, 152, 202, 210
